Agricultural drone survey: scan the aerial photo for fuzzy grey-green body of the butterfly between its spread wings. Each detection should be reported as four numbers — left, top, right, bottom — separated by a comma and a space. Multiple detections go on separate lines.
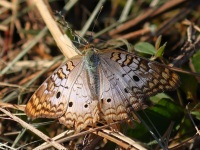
84, 48, 100, 96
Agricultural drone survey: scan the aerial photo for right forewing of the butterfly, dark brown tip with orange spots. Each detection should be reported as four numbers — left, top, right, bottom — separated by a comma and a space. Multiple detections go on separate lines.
102, 51, 180, 96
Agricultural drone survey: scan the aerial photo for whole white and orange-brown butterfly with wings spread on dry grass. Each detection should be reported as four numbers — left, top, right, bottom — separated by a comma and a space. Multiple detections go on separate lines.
25, 47, 180, 132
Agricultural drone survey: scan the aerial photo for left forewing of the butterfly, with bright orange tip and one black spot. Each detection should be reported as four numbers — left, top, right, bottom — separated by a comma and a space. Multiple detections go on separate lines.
25, 59, 81, 119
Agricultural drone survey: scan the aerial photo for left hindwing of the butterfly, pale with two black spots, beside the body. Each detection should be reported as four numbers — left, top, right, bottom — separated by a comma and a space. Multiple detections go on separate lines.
59, 67, 99, 132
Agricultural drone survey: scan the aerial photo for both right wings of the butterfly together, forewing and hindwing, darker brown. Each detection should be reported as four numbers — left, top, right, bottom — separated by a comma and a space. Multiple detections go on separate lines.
100, 51, 179, 121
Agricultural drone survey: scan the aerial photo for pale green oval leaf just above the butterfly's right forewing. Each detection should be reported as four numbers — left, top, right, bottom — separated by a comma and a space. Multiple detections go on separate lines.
134, 42, 156, 55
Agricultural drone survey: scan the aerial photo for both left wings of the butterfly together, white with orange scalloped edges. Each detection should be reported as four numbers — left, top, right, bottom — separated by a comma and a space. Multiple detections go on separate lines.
25, 58, 99, 131
